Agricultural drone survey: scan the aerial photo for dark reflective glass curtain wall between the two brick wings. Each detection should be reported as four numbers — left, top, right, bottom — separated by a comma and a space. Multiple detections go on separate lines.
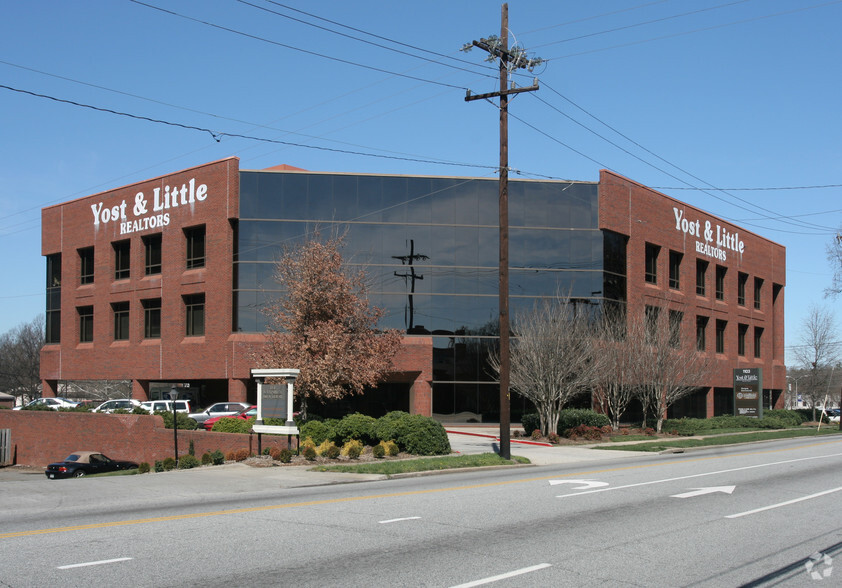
234, 171, 604, 420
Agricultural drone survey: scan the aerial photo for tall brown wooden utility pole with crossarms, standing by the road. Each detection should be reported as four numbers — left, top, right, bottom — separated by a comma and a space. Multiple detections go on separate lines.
465, 4, 541, 459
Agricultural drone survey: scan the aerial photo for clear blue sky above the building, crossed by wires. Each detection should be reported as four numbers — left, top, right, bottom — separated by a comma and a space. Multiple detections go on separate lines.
0, 0, 842, 368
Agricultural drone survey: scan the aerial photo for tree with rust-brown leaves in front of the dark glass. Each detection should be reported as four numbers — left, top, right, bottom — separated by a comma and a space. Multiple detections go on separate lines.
259, 232, 401, 419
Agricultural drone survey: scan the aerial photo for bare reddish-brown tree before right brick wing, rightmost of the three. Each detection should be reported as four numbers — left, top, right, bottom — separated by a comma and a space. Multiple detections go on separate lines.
634, 304, 712, 433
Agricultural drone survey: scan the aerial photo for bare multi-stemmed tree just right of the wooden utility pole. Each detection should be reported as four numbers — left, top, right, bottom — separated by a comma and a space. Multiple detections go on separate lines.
489, 296, 595, 435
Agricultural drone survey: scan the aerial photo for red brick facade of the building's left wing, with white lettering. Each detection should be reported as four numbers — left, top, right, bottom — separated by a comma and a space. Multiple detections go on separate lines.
41, 158, 432, 415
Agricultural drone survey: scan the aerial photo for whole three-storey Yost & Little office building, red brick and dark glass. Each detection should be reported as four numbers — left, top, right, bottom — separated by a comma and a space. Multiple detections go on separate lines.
41, 158, 785, 420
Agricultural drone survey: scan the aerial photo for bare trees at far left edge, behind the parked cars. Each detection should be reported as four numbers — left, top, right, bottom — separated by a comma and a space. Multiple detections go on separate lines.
0, 315, 44, 401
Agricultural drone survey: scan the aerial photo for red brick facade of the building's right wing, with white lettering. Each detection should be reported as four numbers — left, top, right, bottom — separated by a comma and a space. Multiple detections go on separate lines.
599, 170, 786, 408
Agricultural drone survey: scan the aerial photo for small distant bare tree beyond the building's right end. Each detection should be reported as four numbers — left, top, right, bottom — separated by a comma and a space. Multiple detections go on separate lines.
793, 304, 840, 420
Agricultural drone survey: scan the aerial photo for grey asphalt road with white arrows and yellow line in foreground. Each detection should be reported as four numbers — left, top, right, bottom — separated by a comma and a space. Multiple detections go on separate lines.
0, 437, 842, 587
